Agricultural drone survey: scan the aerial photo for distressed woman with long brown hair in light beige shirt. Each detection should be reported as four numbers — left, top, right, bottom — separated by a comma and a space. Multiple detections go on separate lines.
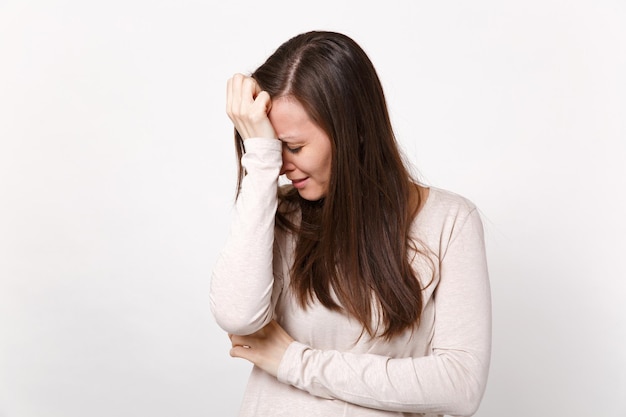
210, 32, 491, 417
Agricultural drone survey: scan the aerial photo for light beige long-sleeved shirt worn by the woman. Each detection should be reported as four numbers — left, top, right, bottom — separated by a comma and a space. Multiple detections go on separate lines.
210, 138, 491, 417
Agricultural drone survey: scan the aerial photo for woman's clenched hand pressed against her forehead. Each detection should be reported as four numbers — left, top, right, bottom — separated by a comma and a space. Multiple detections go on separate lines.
226, 74, 276, 140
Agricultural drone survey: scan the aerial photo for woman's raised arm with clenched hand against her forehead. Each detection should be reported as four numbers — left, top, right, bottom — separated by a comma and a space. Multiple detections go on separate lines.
210, 74, 282, 334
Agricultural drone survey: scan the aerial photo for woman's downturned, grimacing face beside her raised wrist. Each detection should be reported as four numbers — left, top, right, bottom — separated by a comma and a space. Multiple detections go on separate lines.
269, 97, 332, 201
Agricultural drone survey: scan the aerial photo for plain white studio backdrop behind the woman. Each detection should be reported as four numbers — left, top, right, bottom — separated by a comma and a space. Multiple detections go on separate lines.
0, 0, 626, 417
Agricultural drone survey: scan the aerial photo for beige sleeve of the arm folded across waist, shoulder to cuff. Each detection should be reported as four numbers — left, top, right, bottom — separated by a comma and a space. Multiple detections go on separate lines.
278, 209, 491, 416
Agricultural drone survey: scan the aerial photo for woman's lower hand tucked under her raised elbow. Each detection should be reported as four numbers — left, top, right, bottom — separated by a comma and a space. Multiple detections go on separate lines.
228, 320, 294, 377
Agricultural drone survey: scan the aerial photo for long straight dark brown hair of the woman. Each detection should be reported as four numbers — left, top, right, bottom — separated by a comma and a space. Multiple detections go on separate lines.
236, 31, 422, 338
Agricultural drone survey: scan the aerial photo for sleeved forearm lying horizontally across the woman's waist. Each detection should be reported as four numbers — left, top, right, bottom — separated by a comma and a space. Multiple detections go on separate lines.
278, 342, 488, 415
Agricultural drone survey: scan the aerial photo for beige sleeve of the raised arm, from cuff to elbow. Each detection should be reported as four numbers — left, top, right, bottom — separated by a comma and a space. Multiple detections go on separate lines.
209, 138, 282, 334
